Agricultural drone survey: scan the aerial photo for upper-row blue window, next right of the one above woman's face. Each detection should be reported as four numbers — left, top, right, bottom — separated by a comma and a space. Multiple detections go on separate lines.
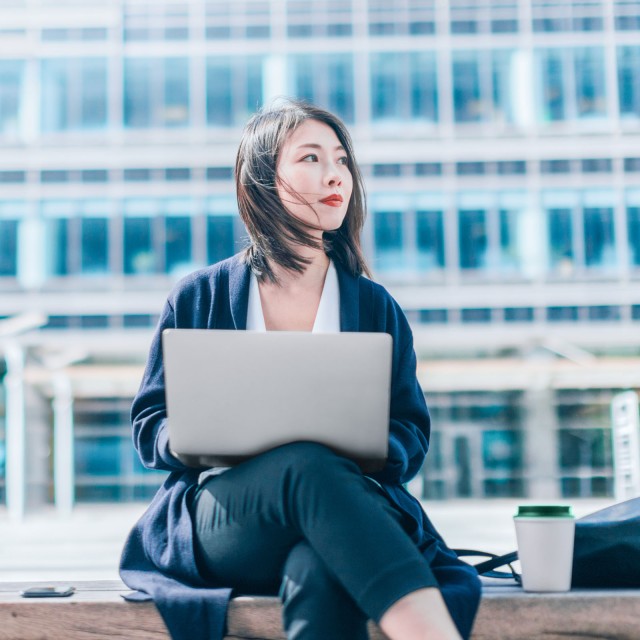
371, 51, 438, 122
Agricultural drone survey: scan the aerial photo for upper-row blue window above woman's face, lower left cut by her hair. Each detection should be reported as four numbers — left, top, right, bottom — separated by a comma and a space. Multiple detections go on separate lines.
290, 53, 354, 122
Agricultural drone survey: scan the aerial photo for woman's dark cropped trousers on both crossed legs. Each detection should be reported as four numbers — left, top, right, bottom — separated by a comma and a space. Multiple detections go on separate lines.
194, 442, 437, 640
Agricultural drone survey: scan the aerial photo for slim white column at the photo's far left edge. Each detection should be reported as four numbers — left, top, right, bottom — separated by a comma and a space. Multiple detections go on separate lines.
4, 342, 26, 520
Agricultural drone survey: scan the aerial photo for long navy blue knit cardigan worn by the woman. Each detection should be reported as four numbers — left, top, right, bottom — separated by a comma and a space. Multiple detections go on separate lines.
120, 256, 480, 640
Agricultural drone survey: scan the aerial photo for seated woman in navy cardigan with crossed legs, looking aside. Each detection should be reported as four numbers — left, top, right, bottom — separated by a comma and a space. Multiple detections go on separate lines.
121, 96, 480, 640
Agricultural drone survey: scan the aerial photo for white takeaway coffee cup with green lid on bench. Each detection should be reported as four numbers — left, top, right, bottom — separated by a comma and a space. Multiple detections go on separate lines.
513, 505, 576, 591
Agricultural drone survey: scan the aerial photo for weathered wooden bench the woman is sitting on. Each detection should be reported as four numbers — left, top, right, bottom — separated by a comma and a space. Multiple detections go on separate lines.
0, 580, 640, 640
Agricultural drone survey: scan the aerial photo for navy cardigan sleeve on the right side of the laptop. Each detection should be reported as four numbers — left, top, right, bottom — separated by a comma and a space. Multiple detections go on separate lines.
370, 301, 431, 484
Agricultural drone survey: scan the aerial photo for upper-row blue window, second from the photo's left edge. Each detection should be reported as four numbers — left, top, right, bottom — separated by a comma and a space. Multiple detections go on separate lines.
41, 58, 107, 131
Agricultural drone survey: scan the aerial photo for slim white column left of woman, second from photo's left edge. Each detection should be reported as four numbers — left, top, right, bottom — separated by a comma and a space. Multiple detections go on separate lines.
53, 372, 75, 516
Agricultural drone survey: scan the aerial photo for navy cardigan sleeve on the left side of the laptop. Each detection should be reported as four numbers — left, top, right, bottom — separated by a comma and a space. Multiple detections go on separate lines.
131, 300, 187, 471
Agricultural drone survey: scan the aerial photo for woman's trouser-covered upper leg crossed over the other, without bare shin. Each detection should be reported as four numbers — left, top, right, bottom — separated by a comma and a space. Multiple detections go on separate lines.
196, 443, 458, 636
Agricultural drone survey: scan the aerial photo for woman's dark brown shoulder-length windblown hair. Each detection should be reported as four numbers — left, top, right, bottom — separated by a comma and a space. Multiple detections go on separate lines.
235, 99, 370, 283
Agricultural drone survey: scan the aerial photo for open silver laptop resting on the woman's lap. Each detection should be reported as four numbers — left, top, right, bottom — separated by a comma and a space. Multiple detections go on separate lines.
162, 329, 392, 472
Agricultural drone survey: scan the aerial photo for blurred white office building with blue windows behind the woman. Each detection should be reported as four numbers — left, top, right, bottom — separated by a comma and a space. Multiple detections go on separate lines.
0, 0, 640, 510
